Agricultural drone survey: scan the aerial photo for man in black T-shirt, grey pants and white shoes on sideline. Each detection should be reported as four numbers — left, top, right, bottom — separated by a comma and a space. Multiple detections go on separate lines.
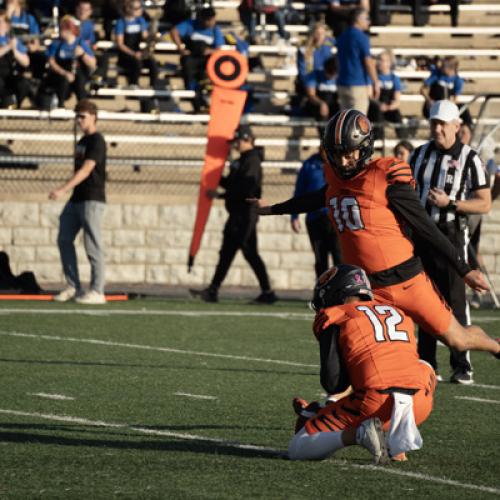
49, 99, 106, 304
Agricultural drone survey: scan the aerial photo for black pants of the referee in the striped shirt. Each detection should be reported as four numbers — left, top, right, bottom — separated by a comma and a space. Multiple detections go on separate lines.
417, 223, 472, 370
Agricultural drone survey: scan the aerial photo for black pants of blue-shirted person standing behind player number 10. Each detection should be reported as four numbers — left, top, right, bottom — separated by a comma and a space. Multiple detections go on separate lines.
306, 214, 342, 278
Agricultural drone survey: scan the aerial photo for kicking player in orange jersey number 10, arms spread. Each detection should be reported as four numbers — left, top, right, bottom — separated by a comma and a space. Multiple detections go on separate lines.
249, 109, 500, 357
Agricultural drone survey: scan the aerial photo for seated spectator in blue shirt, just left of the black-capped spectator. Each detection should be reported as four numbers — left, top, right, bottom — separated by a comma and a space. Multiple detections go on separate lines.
115, 0, 158, 88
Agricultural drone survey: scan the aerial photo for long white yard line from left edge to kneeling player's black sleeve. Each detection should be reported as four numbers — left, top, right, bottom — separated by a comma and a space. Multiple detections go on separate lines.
0, 331, 318, 368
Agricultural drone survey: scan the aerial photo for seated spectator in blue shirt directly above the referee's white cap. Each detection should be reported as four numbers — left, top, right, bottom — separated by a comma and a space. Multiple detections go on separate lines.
420, 56, 472, 124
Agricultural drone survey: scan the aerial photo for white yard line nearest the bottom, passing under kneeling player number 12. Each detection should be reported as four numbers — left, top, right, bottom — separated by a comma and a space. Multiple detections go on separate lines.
0, 409, 500, 495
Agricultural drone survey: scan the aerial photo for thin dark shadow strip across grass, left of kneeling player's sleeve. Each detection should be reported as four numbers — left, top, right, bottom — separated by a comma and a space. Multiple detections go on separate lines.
0, 358, 318, 377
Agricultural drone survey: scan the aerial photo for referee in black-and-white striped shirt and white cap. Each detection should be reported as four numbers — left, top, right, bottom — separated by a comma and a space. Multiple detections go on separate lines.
409, 101, 491, 384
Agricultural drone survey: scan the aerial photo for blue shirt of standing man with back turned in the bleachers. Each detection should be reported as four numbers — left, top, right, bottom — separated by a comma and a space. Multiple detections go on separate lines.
337, 27, 370, 87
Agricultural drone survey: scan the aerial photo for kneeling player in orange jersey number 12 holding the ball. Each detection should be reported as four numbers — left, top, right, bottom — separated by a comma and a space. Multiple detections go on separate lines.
288, 265, 436, 464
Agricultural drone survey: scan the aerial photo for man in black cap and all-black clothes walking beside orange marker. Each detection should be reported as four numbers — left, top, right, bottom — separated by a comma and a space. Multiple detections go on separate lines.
191, 125, 277, 304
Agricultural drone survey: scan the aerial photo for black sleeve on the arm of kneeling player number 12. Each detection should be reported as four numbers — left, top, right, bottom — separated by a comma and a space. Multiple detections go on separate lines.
318, 325, 351, 394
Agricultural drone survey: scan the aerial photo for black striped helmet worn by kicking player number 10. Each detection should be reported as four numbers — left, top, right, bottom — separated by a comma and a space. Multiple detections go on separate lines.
322, 109, 373, 179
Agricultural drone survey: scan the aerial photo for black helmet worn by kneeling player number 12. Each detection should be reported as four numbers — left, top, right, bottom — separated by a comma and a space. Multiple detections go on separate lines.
311, 264, 373, 311
